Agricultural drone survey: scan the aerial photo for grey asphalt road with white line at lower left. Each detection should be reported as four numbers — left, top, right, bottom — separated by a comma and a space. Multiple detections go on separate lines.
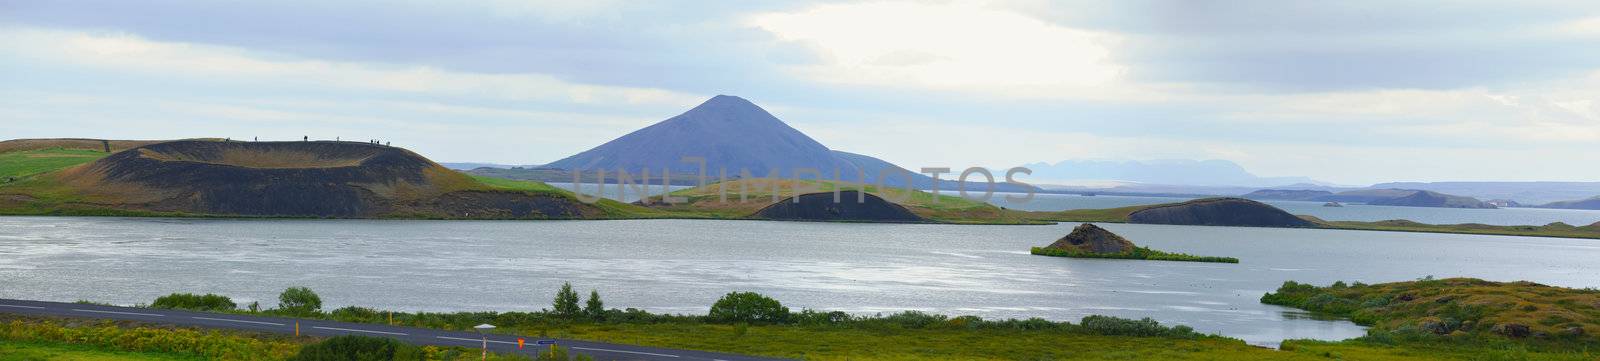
0, 299, 787, 361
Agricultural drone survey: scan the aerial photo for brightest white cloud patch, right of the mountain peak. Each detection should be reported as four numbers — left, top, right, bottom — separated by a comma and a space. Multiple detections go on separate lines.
749, 2, 1125, 97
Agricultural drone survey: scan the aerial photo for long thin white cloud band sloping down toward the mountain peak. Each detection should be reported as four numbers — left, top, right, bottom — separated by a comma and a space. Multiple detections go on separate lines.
0, 27, 704, 107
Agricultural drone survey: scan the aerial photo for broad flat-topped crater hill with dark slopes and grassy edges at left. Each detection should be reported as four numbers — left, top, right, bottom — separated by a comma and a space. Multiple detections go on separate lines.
0, 139, 662, 219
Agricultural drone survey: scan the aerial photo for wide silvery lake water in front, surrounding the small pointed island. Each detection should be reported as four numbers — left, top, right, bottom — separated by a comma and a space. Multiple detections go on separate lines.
0, 217, 1600, 345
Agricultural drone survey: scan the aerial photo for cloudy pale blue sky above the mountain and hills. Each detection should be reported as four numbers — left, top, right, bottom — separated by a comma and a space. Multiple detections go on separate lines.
0, 0, 1600, 185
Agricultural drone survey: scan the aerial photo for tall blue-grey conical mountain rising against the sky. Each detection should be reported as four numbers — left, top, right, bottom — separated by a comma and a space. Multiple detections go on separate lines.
546, 96, 856, 177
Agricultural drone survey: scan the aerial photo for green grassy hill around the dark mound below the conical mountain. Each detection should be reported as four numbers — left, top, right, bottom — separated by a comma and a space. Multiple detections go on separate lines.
650, 179, 1042, 224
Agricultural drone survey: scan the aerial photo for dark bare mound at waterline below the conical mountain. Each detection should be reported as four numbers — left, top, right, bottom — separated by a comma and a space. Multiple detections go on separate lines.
755, 190, 925, 222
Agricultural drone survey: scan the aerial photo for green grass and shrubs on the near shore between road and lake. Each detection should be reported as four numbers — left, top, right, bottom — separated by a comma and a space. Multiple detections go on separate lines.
28, 284, 1574, 359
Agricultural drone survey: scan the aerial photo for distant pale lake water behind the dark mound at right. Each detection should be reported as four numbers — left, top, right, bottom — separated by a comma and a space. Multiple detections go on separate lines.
970, 193, 1600, 225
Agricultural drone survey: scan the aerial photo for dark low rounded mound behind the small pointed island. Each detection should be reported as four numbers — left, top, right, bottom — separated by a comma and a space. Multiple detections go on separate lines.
1128, 198, 1315, 227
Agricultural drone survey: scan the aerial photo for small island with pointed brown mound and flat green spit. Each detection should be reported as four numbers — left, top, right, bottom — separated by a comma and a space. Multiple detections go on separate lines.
1032, 224, 1238, 264
